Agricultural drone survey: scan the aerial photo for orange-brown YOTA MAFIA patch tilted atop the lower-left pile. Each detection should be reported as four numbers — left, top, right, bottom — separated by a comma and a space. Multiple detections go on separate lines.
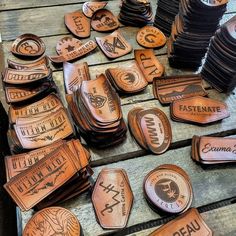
4, 145, 78, 211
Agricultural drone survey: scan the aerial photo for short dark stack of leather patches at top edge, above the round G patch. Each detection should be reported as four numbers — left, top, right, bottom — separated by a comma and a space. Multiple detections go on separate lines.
118, 0, 153, 27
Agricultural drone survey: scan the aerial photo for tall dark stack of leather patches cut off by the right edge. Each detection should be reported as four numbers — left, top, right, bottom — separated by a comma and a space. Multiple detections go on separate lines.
201, 16, 236, 92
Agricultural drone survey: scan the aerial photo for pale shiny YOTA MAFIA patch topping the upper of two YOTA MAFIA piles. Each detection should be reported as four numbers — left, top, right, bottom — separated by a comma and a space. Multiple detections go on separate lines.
14, 108, 73, 149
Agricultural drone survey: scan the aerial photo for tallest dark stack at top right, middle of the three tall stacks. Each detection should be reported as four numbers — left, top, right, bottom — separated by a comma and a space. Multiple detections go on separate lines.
168, 0, 227, 69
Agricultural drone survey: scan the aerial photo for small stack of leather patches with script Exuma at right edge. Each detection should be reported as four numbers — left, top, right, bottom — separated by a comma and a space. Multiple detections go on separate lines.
191, 135, 236, 165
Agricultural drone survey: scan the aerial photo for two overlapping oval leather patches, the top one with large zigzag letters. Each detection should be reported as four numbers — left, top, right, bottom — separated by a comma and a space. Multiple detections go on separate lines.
128, 107, 172, 154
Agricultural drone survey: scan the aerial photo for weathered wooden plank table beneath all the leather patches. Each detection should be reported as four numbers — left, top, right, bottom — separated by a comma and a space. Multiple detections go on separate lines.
0, 0, 236, 236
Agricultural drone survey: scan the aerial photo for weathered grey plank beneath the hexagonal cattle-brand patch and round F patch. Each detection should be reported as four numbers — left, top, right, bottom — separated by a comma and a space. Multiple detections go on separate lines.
19, 146, 236, 235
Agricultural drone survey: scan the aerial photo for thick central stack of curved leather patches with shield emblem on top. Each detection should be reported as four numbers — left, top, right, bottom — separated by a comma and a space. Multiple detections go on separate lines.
67, 74, 127, 147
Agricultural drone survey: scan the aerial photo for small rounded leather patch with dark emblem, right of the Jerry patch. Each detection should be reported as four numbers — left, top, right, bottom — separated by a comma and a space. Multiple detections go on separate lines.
91, 9, 119, 32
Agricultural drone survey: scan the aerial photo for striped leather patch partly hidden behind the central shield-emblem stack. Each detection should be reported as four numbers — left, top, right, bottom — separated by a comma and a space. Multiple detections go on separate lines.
63, 62, 90, 94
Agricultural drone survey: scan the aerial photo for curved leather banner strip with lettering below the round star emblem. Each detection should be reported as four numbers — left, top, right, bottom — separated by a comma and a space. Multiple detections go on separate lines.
49, 40, 97, 63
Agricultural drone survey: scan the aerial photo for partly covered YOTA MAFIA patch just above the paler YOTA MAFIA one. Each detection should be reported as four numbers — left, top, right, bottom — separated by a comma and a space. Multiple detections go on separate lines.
8, 93, 63, 123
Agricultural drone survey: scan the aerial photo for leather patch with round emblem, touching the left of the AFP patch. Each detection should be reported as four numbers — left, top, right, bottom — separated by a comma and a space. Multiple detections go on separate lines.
106, 62, 148, 93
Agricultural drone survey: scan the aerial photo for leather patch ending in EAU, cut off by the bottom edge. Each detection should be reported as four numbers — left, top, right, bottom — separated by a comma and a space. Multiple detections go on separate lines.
149, 208, 213, 236
